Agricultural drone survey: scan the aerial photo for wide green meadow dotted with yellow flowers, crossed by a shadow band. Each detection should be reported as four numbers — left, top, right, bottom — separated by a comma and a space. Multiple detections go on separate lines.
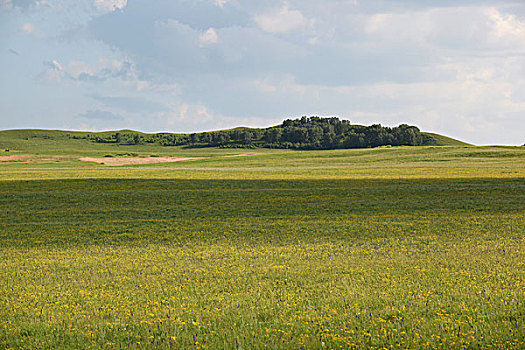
0, 132, 525, 349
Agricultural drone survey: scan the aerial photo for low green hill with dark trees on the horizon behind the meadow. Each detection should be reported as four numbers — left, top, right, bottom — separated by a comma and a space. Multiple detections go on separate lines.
0, 117, 468, 150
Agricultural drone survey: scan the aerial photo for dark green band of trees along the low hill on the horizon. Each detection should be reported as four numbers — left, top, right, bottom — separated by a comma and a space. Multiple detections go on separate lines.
76, 116, 428, 150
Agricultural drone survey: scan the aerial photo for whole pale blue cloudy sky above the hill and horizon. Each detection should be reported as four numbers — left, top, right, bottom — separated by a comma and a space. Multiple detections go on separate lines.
0, 0, 525, 145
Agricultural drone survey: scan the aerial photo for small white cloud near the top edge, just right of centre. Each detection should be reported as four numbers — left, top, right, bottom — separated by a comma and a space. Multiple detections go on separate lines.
254, 2, 313, 33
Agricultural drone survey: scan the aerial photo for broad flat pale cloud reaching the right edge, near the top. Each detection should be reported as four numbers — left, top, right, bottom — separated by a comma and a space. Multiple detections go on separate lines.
364, 6, 525, 53
